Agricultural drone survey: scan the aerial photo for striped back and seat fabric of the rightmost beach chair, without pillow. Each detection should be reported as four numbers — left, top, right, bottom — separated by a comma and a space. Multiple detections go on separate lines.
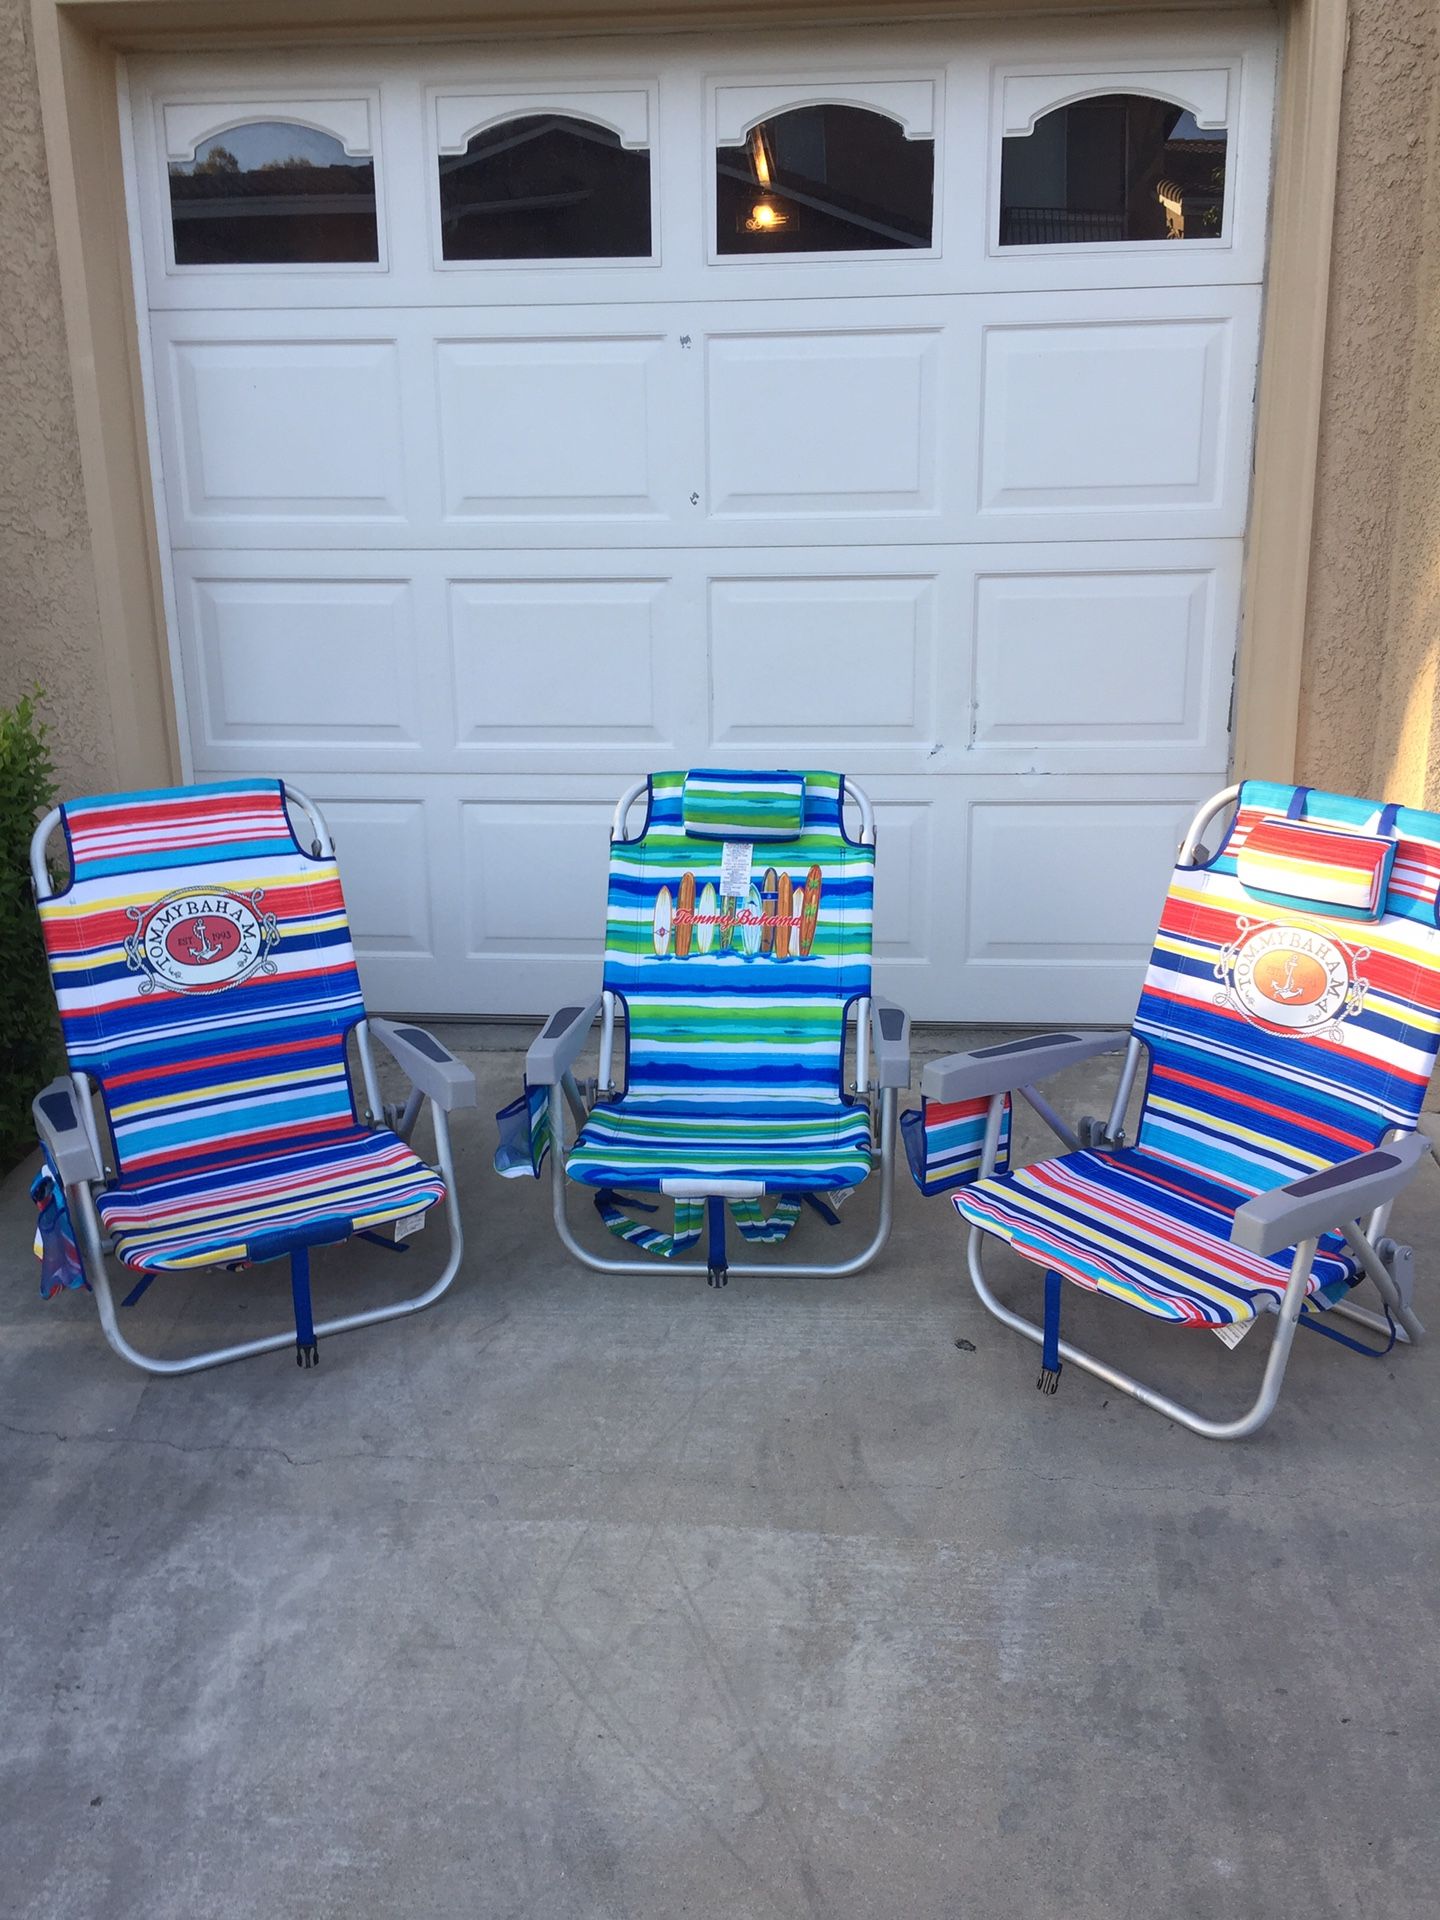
954, 781, 1440, 1327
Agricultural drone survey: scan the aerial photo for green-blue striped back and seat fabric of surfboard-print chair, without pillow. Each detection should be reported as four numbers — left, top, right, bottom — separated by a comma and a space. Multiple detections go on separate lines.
566, 774, 876, 1192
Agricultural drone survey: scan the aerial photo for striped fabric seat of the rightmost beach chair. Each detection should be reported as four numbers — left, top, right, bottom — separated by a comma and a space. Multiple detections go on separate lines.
954, 1148, 1359, 1327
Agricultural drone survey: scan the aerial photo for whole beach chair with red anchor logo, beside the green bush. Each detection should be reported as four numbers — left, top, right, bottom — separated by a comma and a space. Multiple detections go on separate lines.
31, 780, 474, 1373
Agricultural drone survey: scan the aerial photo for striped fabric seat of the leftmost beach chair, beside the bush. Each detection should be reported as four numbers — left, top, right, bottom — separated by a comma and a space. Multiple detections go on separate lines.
96, 1127, 445, 1269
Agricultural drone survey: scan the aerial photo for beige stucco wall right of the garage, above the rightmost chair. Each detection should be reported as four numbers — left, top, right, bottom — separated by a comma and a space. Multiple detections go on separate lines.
1300, 0, 1440, 804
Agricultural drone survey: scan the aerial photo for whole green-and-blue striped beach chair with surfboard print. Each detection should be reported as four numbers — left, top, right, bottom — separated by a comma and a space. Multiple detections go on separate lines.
515, 768, 910, 1284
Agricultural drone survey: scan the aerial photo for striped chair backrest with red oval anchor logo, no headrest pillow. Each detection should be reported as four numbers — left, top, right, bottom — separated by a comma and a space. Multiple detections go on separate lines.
38, 780, 365, 1175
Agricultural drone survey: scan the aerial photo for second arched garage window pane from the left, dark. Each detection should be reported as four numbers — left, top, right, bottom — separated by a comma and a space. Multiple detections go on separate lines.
440, 113, 651, 259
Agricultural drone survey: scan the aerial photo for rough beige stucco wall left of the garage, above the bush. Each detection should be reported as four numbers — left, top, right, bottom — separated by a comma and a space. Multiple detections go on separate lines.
0, 0, 115, 791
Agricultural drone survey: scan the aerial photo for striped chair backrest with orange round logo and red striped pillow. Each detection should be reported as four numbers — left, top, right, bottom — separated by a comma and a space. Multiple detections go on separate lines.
1135, 781, 1440, 1194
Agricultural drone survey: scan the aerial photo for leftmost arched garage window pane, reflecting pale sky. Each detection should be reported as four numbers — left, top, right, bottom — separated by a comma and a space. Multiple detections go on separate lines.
171, 121, 380, 267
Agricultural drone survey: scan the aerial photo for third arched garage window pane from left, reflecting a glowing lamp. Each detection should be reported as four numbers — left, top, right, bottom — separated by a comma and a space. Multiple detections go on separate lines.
714, 106, 935, 253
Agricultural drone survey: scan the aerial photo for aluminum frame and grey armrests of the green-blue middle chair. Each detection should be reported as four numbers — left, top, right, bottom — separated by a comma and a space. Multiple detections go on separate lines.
526, 776, 910, 1279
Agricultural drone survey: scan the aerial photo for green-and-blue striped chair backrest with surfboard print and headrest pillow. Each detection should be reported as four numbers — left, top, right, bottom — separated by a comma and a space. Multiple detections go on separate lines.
605, 768, 876, 1098
